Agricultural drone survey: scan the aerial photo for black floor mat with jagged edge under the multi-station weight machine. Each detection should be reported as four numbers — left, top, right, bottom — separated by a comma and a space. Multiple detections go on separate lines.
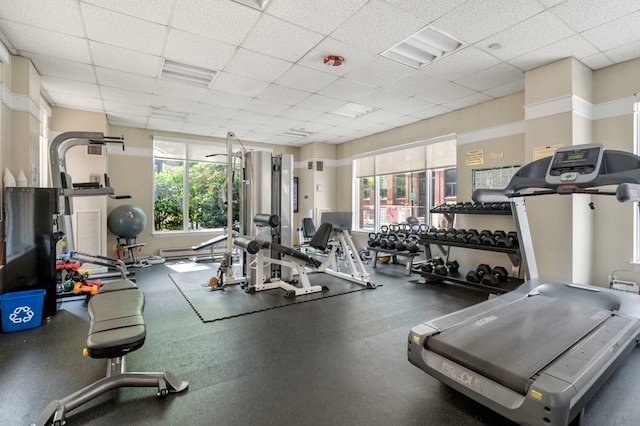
169, 269, 366, 322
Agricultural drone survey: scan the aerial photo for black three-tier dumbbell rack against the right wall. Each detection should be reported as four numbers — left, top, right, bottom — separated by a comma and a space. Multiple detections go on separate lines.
414, 203, 524, 293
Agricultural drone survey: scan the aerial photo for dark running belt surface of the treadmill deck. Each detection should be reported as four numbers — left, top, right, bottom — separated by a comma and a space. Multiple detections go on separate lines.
425, 296, 612, 395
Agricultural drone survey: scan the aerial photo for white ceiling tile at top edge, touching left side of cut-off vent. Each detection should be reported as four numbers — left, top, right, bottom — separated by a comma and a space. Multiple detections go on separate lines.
171, 0, 260, 45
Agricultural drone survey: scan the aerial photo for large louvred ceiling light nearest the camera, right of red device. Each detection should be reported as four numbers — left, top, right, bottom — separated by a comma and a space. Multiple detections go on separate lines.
382, 27, 462, 68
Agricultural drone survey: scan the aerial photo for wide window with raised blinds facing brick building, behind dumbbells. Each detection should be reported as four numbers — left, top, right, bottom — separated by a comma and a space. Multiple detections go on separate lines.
354, 137, 456, 232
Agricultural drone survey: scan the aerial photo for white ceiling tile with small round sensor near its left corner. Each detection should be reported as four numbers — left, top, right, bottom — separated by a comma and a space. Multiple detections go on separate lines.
479, 12, 573, 61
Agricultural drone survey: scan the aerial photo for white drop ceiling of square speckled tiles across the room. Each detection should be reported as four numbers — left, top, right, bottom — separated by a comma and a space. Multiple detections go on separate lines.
0, 0, 640, 146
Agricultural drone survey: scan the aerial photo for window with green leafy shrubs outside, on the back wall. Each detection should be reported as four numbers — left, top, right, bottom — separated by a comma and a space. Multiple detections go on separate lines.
153, 138, 240, 231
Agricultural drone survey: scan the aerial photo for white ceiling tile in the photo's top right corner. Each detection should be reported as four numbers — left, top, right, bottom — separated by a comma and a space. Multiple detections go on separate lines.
551, 0, 640, 32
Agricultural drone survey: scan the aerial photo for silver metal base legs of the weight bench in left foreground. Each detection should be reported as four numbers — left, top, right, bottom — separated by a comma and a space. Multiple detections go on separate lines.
32, 358, 189, 426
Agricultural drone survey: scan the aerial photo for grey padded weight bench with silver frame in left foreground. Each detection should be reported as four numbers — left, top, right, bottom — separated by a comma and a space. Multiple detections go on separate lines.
32, 279, 189, 426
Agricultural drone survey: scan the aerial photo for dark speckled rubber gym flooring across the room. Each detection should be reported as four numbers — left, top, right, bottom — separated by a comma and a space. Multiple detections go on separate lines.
0, 265, 640, 426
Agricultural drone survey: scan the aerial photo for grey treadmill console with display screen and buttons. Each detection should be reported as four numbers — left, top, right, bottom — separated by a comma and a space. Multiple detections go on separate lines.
545, 144, 604, 185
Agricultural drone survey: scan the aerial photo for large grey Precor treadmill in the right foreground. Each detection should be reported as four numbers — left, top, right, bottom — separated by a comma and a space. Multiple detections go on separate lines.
408, 144, 640, 426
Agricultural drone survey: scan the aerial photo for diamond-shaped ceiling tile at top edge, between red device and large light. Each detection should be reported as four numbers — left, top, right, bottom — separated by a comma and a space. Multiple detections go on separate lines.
331, 0, 426, 53
